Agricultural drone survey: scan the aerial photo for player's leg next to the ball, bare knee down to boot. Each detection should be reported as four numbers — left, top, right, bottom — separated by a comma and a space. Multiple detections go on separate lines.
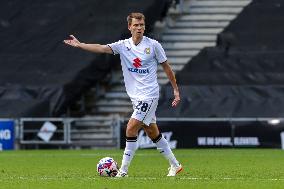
116, 118, 142, 177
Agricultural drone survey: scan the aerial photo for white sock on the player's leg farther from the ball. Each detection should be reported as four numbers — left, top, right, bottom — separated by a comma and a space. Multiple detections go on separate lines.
153, 134, 179, 166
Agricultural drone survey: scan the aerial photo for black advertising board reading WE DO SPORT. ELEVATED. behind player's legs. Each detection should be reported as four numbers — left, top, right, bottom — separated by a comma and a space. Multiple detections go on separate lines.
121, 119, 284, 148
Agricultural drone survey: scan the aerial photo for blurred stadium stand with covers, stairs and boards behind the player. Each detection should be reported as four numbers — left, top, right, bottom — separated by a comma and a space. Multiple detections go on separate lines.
0, 0, 284, 150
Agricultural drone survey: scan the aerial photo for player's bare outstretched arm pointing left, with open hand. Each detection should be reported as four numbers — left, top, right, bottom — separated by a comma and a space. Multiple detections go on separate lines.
63, 35, 112, 54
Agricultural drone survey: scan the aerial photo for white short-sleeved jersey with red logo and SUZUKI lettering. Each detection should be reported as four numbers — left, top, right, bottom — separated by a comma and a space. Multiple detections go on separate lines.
108, 36, 167, 100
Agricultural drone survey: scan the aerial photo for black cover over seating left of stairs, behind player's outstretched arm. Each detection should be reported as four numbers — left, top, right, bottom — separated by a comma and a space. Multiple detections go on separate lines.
0, 0, 168, 117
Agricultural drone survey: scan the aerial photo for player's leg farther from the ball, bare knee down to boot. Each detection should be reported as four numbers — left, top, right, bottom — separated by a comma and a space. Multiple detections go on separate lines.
142, 123, 182, 176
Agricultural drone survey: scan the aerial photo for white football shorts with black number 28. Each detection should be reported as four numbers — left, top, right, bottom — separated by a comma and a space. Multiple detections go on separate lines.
131, 98, 159, 126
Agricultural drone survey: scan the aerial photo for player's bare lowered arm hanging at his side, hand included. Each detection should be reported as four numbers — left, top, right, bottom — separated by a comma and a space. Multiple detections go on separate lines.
162, 61, 180, 107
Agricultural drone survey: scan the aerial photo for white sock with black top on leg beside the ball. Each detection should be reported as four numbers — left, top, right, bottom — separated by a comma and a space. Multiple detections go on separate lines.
120, 137, 137, 173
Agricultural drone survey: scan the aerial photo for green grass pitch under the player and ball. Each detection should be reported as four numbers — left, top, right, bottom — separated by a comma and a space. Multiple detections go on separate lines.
0, 149, 284, 189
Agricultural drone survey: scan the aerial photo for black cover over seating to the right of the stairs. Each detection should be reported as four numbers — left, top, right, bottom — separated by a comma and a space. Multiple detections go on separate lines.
158, 0, 284, 117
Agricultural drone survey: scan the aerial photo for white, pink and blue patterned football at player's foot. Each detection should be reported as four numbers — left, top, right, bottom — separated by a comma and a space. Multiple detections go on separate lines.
97, 157, 119, 177
